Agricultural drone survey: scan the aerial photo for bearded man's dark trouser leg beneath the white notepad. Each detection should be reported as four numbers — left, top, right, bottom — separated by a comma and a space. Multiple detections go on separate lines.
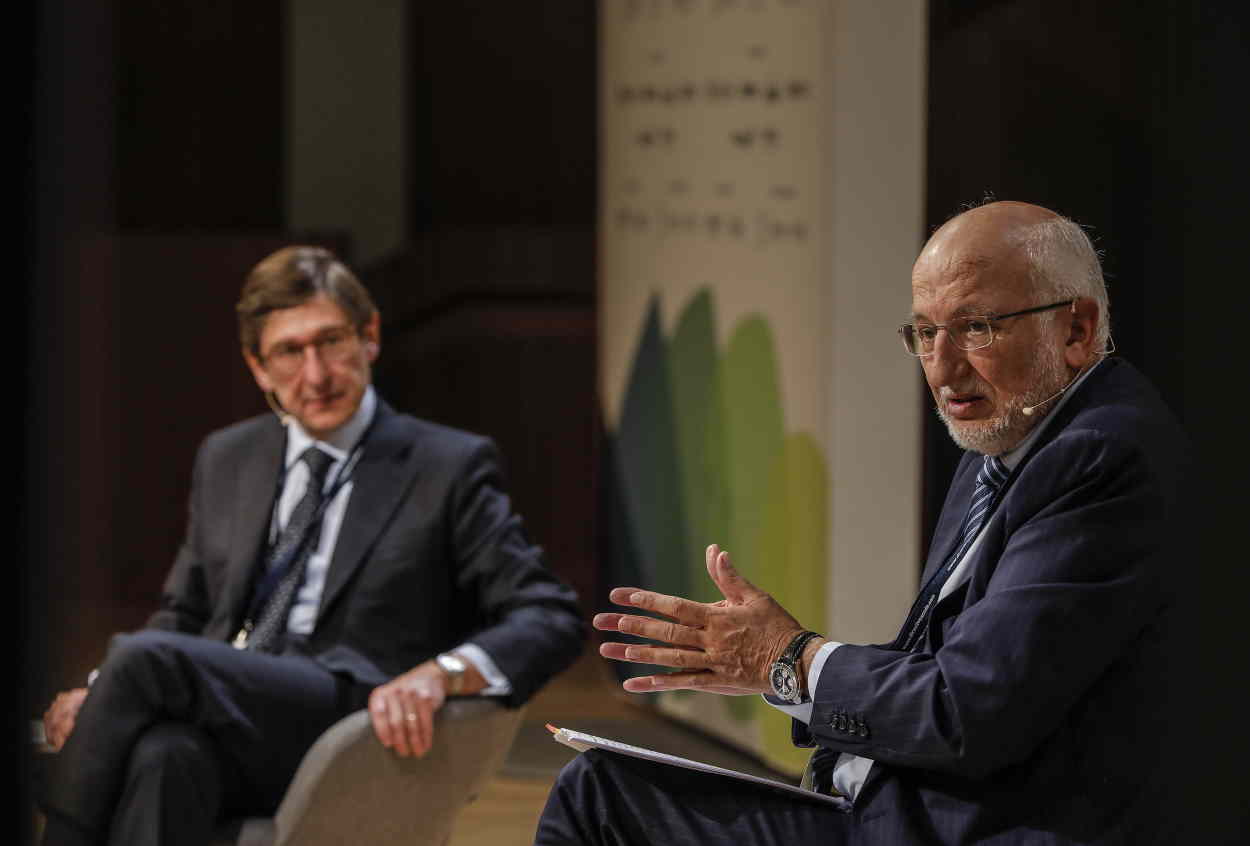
534, 750, 850, 846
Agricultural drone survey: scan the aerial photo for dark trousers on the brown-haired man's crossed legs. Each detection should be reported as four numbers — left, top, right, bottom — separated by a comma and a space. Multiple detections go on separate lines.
41, 631, 350, 844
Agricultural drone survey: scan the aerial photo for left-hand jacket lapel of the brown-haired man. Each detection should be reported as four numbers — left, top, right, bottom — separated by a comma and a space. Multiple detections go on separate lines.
224, 421, 286, 624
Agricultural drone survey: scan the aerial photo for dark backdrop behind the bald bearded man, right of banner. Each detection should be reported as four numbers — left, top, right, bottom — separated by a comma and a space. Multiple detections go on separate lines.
924, 0, 1250, 829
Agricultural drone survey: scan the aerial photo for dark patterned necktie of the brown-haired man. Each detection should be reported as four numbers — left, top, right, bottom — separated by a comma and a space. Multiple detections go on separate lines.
248, 446, 334, 652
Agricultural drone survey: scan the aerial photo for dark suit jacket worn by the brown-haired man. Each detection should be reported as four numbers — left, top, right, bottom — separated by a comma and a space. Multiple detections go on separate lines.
149, 401, 585, 705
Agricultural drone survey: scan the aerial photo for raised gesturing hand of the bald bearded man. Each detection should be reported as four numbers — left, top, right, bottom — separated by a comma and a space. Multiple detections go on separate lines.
594, 544, 804, 695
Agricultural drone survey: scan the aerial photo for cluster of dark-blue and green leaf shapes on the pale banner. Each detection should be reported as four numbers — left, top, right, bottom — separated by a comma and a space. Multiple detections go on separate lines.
603, 289, 829, 770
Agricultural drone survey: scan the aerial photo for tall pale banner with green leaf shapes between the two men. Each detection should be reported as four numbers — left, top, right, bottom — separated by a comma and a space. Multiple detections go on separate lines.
598, 0, 928, 775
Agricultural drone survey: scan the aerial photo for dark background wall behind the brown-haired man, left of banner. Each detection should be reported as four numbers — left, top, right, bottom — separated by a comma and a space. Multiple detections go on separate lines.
26, 0, 595, 702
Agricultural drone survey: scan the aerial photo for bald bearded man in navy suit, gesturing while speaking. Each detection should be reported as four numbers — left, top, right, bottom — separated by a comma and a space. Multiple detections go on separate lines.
536, 202, 1190, 846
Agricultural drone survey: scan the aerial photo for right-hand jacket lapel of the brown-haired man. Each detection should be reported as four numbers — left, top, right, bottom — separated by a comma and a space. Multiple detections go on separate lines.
318, 401, 416, 622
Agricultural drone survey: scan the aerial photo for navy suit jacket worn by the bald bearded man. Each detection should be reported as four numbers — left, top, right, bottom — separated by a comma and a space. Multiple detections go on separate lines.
798, 359, 1189, 844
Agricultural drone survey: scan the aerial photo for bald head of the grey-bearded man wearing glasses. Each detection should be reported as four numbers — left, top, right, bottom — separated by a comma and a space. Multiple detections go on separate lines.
911, 202, 1106, 455
